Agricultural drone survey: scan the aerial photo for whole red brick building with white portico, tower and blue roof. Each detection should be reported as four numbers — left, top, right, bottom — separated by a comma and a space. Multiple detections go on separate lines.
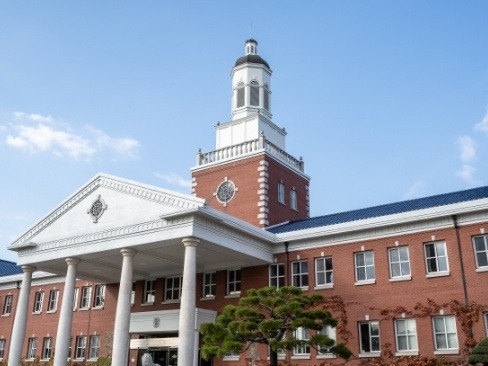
0, 40, 488, 366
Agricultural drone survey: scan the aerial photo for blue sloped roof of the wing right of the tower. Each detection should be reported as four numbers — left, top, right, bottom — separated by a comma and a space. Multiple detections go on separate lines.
267, 186, 488, 234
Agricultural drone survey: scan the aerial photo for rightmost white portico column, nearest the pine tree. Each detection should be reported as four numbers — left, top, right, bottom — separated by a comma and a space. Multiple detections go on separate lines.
178, 238, 200, 366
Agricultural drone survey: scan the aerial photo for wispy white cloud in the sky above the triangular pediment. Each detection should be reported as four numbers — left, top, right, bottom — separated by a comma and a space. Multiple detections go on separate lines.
6, 112, 141, 160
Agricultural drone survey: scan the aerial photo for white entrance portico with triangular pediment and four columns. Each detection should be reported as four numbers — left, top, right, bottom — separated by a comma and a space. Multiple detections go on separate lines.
9, 174, 274, 366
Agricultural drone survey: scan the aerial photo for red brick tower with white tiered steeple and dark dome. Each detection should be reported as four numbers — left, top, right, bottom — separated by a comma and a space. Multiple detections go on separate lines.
191, 39, 310, 227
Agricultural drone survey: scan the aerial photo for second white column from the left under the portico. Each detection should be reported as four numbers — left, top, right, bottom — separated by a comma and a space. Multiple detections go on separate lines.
54, 258, 80, 366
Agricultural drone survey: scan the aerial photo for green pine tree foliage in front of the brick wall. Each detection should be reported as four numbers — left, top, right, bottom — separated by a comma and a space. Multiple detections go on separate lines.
201, 286, 351, 359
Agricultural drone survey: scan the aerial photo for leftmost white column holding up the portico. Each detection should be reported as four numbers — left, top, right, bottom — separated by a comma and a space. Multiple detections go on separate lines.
8, 266, 35, 366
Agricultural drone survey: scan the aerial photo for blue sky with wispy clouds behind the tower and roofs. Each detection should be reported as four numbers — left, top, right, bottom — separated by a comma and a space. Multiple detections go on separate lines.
0, 0, 488, 261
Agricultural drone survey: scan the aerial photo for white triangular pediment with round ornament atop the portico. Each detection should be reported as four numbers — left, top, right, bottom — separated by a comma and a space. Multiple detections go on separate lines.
9, 174, 205, 250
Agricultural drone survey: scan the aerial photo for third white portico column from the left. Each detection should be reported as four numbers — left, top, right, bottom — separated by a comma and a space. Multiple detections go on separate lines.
112, 249, 136, 366
